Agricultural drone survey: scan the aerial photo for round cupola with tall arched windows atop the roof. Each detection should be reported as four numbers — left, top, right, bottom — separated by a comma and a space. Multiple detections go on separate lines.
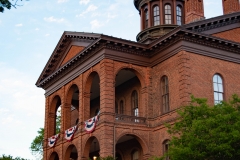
134, 0, 185, 44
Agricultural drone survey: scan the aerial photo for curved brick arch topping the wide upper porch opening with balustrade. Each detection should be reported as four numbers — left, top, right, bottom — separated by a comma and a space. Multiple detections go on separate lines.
114, 66, 146, 88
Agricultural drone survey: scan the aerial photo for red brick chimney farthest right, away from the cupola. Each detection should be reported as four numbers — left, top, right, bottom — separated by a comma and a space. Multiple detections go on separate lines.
222, 0, 240, 14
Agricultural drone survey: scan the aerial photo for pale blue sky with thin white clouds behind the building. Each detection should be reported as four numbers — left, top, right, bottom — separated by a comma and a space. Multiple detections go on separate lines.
0, 0, 222, 160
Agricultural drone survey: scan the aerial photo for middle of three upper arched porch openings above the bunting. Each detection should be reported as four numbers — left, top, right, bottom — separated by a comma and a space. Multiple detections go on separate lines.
65, 84, 79, 129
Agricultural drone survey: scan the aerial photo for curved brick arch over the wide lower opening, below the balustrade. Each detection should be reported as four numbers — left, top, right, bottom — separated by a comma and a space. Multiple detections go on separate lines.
116, 132, 148, 155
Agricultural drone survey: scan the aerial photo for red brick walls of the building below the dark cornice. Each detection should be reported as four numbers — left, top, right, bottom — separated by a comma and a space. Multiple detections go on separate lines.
44, 54, 240, 160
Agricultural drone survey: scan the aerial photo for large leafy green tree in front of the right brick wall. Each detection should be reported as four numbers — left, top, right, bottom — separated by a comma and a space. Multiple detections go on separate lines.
162, 95, 240, 160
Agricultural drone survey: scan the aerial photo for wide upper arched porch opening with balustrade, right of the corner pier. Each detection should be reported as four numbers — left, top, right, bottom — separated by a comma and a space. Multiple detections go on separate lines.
115, 69, 144, 122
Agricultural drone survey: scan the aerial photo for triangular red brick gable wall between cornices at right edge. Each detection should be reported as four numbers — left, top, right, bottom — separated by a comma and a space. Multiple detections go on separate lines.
213, 28, 240, 43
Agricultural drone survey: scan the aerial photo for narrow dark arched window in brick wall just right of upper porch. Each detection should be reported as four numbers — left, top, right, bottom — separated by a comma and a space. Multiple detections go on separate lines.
161, 76, 169, 113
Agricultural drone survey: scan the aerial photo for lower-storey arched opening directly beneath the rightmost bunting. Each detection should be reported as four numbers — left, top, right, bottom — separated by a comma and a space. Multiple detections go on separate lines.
83, 137, 100, 160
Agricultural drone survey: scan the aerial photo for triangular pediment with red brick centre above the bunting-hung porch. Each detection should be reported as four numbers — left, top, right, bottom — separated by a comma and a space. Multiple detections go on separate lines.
36, 32, 100, 84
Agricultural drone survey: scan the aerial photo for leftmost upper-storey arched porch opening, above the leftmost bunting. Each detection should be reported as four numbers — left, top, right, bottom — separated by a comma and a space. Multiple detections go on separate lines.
48, 96, 62, 137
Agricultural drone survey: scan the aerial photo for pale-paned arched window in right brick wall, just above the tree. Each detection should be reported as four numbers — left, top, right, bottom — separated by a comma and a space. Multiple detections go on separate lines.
213, 74, 224, 104
